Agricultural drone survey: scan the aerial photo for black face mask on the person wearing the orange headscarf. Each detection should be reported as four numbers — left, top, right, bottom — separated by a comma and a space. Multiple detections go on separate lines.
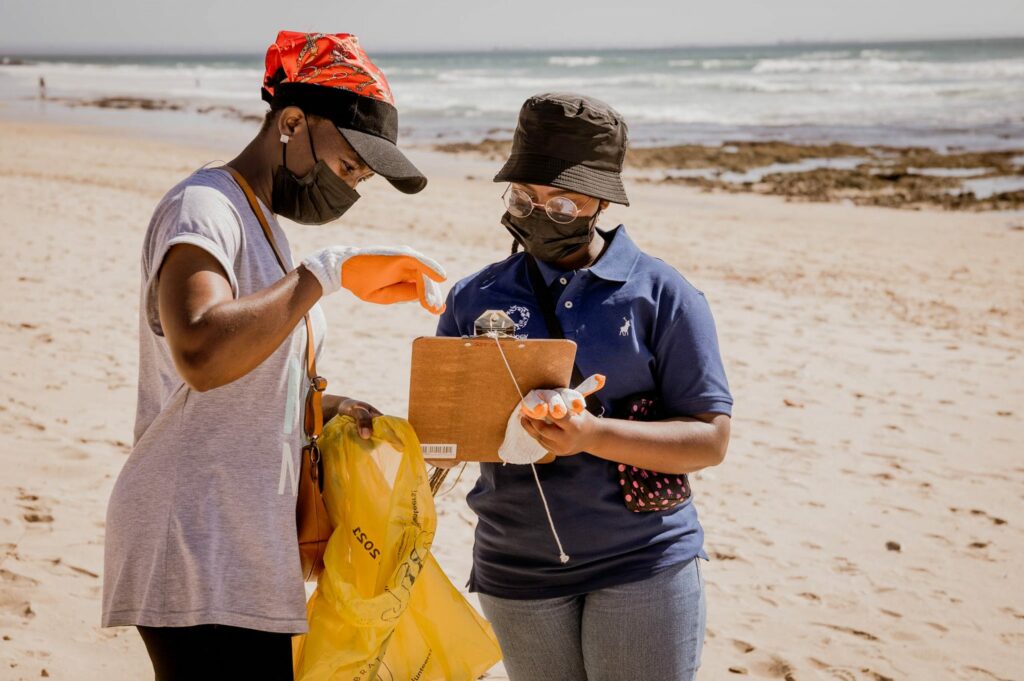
270, 126, 359, 224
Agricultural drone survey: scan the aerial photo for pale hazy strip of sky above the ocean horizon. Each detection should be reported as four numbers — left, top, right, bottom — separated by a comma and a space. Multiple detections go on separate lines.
0, 0, 1024, 53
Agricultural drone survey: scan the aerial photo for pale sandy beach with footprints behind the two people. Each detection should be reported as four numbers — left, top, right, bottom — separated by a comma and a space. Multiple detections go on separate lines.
0, 120, 1024, 681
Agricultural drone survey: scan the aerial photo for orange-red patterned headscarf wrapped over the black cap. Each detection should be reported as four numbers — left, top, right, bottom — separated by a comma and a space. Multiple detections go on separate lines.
263, 31, 394, 105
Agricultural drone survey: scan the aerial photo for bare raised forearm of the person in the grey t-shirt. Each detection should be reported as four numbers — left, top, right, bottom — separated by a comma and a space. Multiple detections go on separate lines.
176, 267, 322, 390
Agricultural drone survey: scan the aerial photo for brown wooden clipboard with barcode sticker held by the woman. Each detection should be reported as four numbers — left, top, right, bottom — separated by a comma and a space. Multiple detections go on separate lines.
409, 336, 577, 462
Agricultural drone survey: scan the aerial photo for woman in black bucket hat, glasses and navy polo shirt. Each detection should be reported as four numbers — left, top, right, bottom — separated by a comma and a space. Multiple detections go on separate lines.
437, 94, 732, 681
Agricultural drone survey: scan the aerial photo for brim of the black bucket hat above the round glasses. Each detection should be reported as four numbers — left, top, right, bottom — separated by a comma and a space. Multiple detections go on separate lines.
495, 154, 630, 206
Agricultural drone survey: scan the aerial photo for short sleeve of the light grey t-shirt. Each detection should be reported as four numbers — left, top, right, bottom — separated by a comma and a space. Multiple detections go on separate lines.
142, 185, 242, 336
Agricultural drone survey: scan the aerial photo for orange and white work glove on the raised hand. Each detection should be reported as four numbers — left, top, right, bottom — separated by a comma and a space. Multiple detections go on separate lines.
302, 246, 446, 314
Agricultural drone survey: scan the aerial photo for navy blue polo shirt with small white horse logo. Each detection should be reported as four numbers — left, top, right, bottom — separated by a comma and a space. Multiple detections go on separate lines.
437, 225, 732, 599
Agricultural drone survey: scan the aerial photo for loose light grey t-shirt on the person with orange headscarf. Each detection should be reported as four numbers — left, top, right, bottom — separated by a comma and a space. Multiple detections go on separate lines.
102, 168, 326, 633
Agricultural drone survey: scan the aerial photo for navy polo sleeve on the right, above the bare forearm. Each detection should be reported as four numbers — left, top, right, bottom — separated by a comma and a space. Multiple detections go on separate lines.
654, 289, 732, 416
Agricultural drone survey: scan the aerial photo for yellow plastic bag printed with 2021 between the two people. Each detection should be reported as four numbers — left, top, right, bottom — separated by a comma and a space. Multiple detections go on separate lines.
293, 417, 501, 681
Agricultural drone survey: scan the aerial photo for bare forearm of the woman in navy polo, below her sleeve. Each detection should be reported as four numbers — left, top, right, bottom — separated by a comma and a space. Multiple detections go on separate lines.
587, 414, 729, 474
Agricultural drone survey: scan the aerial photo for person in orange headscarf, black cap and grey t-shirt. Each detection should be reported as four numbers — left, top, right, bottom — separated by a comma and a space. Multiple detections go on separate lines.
102, 32, 443, 681
